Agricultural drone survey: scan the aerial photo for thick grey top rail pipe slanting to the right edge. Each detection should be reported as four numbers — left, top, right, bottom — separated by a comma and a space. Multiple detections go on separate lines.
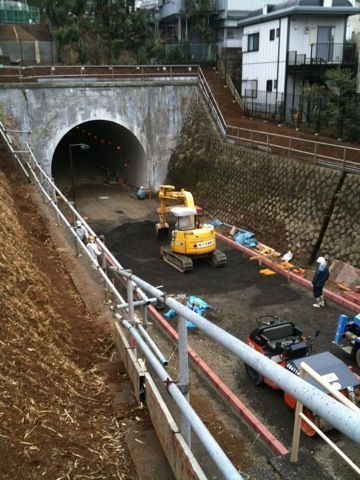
115, 270, 360, 443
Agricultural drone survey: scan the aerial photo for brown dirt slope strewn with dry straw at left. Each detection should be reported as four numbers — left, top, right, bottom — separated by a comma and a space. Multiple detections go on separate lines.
0, 147, 133, 480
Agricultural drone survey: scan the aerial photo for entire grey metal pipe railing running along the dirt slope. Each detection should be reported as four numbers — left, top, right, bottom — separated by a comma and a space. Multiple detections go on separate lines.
0, 125, 360, 479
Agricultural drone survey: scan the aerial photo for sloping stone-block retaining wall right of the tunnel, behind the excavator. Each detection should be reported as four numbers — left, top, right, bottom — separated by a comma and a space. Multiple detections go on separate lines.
168, 94, 360, 267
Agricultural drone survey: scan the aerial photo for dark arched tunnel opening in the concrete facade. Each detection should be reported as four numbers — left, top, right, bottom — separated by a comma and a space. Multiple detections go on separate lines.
52, 120, 147, 201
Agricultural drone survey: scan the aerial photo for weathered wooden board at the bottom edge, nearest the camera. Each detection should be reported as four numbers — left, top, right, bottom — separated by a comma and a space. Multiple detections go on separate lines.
145, 373, 206, 480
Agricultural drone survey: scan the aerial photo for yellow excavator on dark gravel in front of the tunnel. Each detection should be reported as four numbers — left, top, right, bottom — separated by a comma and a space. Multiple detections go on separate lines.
156, 185, 227, 272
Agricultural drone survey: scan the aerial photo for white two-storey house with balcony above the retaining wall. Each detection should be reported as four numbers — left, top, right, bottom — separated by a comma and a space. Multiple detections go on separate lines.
239, 0, 360, 114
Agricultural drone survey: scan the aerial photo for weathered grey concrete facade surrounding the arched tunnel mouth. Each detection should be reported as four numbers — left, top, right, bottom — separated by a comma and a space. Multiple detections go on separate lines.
0, 79, 196, 189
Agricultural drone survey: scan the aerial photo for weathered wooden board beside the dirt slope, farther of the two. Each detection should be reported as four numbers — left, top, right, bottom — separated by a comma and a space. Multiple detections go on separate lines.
114, 323, 145, 402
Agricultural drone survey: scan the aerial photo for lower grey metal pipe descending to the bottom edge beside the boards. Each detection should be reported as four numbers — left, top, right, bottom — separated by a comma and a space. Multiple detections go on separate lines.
121, 320, 242, 480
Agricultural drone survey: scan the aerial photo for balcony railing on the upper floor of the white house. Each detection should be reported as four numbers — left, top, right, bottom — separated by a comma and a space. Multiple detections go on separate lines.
287, 42, 355, 66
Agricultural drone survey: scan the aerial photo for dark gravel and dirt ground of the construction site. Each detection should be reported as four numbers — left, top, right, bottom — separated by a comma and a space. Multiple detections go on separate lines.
68, 171, 359, 479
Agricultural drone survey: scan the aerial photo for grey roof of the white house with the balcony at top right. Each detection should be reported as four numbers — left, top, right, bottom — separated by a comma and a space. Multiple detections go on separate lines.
239, 0, 360, 26
